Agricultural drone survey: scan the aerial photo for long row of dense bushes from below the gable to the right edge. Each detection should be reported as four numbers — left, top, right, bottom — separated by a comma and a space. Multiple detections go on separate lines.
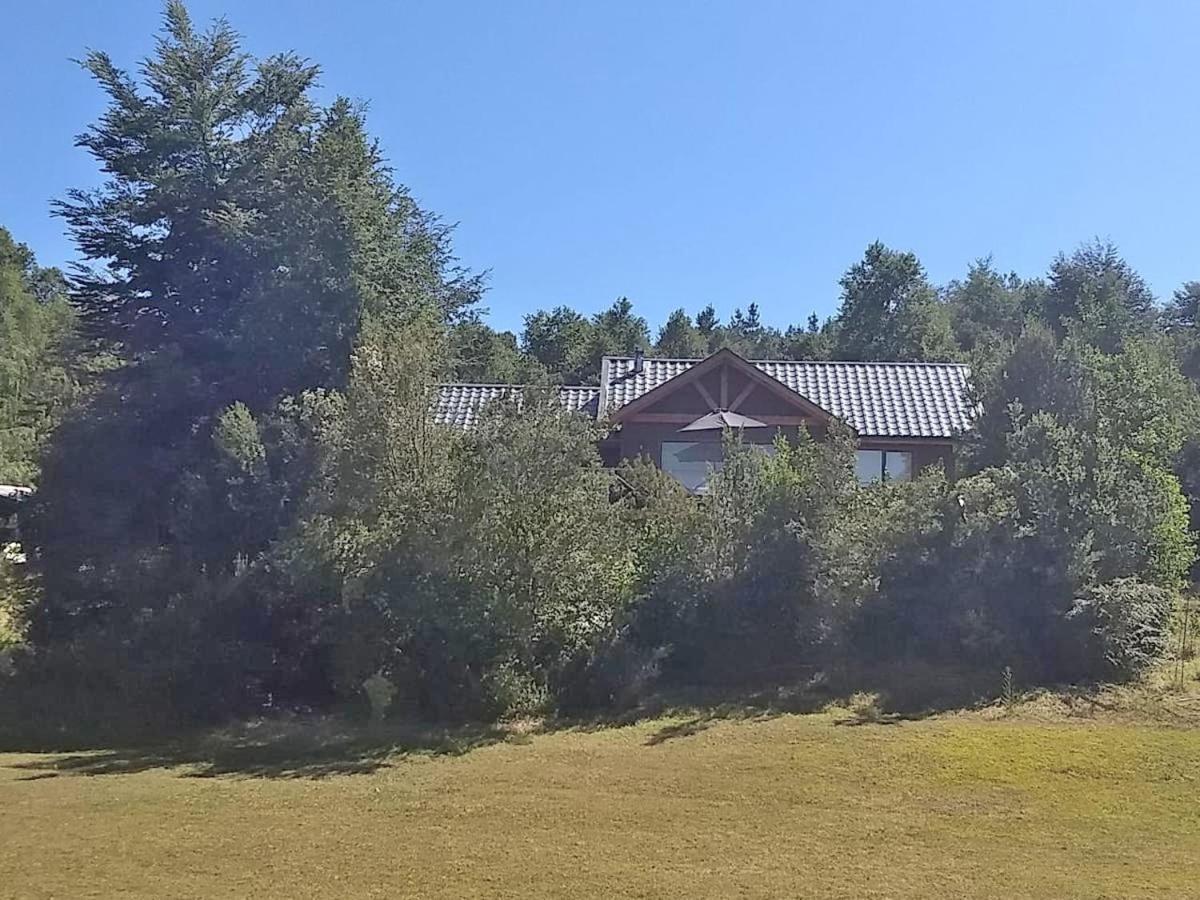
619, 414, 1193, 696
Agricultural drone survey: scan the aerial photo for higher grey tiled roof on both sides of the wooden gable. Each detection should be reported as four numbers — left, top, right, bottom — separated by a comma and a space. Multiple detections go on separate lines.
604, 356, 972, 438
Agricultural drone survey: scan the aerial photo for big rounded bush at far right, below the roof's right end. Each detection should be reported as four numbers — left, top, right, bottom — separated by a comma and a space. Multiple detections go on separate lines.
853, 413, 1193, 680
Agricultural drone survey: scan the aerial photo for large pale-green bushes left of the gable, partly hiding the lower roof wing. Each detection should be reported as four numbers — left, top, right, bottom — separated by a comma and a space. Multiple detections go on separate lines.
232, 323, 635, 716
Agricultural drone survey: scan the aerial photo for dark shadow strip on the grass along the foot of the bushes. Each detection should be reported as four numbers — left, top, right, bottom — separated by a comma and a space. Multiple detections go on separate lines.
0, 666, 1022, 780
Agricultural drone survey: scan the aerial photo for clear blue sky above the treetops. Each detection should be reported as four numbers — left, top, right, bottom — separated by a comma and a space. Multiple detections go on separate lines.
0, 0, 1200, 328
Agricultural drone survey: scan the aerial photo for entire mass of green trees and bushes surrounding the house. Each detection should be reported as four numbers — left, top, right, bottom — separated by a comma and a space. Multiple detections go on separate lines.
0, 1, 1200, 734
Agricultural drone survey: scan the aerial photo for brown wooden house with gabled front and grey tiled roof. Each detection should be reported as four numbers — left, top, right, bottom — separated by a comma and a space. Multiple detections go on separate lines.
436, 349, 972, 491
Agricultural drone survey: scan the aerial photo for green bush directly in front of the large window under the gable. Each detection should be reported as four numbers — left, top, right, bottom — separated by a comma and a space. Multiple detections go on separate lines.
636, 434, 858, 683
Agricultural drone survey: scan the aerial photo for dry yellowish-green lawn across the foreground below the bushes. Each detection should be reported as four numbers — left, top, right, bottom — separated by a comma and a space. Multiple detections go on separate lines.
0, 681, 1200, 898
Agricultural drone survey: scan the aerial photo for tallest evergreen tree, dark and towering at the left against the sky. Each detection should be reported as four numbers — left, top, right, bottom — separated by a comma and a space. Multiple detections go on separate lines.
30, 2, 479, 637
